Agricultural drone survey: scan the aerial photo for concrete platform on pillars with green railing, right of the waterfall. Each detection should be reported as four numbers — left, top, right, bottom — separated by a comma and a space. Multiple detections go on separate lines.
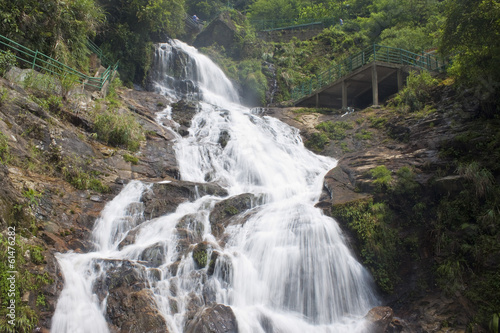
292, 45, 444, 109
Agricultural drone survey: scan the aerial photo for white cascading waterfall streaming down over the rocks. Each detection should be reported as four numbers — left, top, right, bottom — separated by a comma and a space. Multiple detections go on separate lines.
52, 41, 376, 333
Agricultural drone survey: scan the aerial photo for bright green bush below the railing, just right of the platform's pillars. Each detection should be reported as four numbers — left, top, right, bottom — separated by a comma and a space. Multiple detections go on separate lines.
394, 71, 437, 112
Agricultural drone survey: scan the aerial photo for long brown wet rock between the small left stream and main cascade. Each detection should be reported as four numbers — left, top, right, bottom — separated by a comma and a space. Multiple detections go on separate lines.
142, 181, 227, 219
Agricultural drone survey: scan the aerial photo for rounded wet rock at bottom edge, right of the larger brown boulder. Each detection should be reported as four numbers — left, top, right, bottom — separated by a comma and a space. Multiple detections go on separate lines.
186, 304, 238, 333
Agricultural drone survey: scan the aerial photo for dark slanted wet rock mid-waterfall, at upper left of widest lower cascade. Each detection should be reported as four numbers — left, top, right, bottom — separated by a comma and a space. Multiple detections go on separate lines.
209, 193, 259, 238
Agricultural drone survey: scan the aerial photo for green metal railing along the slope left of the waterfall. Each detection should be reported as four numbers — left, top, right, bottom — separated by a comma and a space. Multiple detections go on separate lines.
0, 35, 118, 90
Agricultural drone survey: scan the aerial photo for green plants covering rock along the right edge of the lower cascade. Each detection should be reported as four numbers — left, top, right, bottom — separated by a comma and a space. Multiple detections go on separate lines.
332, 199, 399, 293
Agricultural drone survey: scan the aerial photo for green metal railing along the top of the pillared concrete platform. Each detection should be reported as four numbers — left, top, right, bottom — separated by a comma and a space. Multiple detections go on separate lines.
291, 44, 446, 100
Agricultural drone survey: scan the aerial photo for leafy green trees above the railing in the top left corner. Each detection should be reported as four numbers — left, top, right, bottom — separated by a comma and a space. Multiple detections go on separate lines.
0, 0, 105, 70
